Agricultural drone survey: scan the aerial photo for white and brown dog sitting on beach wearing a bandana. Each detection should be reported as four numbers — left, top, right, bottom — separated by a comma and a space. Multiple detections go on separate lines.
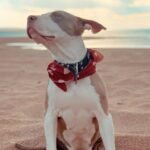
27, 11, 115, 150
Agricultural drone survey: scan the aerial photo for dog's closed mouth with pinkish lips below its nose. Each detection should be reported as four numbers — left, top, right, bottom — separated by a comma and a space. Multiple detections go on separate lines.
27, 27, 55, 40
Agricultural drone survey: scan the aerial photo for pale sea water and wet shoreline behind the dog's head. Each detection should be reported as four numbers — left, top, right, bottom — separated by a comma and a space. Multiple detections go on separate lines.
0, 29, 150, 50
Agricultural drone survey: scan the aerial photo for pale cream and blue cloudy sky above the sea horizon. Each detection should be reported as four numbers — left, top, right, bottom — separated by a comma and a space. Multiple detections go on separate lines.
0, 0, 150, 30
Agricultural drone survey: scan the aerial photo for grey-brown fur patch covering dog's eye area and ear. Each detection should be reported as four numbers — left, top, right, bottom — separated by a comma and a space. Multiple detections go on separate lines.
50, 11, 106, 36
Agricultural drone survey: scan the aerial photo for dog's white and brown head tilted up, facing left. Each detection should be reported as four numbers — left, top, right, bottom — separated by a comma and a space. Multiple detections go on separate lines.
27, 11, 106, 43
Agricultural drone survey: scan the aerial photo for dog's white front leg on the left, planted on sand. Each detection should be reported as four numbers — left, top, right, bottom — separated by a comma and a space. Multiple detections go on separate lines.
44, 92, 57, 150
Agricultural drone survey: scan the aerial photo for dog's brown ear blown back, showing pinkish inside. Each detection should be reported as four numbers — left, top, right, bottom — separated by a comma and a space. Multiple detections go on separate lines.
80, 18, 106, 33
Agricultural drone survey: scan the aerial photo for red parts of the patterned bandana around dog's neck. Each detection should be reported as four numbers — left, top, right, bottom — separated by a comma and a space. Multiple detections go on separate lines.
47, 49, 103, 92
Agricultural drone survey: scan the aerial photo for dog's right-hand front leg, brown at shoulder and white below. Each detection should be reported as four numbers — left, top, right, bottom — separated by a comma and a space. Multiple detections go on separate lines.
91, 74, 115, 150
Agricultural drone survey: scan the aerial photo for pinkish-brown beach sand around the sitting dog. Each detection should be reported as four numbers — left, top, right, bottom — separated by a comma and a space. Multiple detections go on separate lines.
0, 38, 150, 150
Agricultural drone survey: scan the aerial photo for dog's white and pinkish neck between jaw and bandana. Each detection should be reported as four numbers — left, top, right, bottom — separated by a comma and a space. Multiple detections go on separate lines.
45, 36, 87, 63
